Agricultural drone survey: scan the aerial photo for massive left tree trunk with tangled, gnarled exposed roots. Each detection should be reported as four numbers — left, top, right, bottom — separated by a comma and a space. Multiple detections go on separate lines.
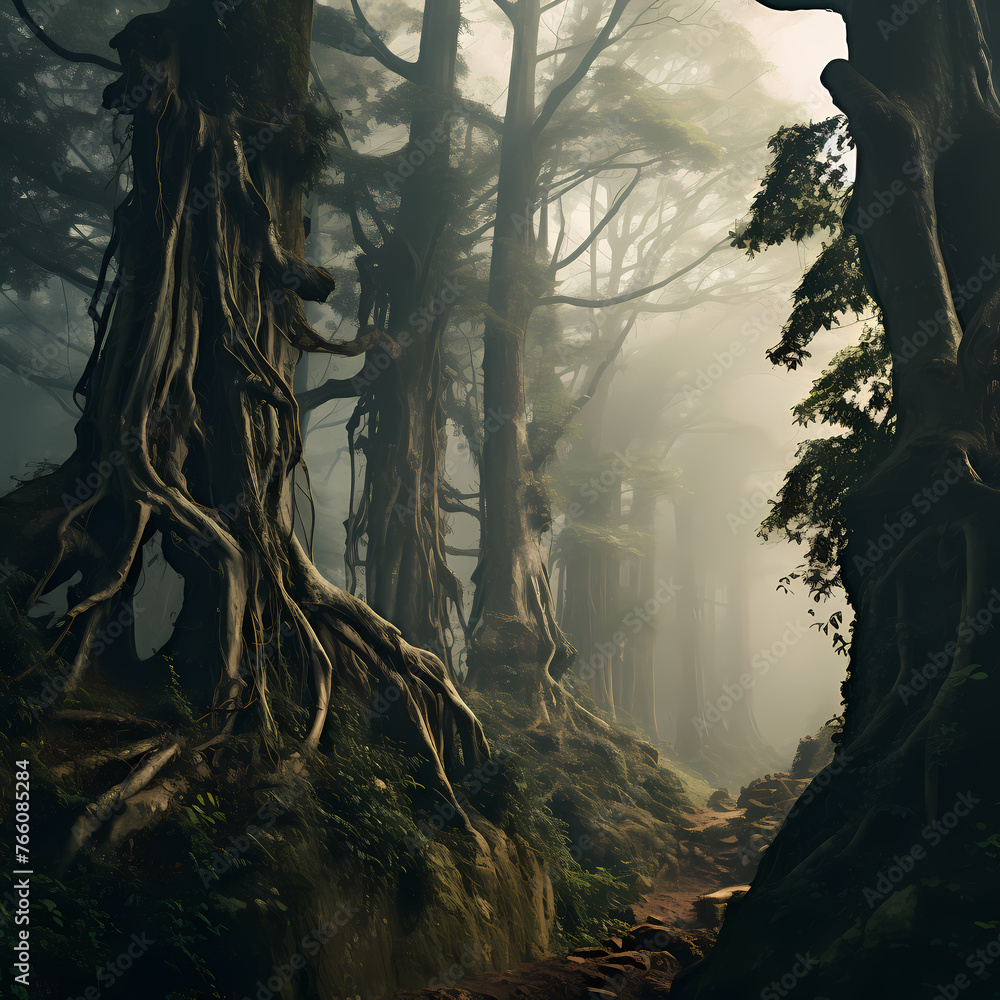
0, 0, 485, 853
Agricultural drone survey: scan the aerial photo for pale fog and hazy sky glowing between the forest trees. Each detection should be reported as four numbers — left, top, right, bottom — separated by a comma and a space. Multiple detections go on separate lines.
0, 0, 855, 780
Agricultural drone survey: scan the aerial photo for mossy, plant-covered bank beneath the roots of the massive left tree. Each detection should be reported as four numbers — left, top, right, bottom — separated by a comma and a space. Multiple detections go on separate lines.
0, 622, 688, 1000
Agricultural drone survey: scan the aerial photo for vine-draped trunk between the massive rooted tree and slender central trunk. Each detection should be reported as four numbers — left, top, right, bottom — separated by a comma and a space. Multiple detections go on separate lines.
348, 0, 462, 667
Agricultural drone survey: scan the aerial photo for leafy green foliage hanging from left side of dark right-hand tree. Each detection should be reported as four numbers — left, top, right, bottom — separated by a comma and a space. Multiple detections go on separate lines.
735, 118, 895, 620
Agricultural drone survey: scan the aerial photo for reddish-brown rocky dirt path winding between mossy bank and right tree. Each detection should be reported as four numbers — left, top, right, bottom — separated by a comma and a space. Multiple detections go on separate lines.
383, 774, 809, 1000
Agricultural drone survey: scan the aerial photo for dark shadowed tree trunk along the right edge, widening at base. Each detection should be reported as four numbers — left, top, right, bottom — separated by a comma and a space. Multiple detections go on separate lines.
672, 0, 1000, 1000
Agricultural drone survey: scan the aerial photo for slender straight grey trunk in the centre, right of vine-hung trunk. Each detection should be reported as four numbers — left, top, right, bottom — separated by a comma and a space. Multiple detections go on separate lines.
469, 0, 573, 710
